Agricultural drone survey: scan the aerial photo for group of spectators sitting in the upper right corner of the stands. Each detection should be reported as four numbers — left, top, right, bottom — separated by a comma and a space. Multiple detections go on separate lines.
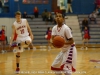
82, 0, 100, 31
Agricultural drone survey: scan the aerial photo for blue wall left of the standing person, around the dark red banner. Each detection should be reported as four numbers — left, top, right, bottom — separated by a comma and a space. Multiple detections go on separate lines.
0, 0, 52, 17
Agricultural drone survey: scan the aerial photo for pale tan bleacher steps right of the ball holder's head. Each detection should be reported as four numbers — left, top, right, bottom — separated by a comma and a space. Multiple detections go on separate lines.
65, 15, 82, 44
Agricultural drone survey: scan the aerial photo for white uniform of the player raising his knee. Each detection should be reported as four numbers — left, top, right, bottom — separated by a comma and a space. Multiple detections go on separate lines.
13, 19, 32, 52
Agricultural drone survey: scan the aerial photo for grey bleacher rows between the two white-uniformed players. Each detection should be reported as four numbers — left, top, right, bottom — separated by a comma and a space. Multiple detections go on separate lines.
28, 16, 54, 45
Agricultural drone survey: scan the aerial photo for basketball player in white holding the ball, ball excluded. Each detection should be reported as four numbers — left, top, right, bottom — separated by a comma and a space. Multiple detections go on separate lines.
51, 13, 77, 75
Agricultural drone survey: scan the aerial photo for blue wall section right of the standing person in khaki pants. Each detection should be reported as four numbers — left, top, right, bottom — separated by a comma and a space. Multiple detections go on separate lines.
72, 0, 94, 14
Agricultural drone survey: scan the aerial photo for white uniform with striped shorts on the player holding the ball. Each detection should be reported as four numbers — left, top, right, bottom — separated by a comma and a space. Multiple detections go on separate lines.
51, 24, 77, 75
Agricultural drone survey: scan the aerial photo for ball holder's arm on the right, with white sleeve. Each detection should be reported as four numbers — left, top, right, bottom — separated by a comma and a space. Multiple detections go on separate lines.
65, 29, 74, 45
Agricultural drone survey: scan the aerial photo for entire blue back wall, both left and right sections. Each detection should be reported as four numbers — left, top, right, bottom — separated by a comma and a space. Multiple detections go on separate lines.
0, 0, 94, 17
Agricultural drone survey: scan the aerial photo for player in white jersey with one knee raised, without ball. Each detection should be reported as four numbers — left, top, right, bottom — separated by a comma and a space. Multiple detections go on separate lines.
10, 11, 33, 73
